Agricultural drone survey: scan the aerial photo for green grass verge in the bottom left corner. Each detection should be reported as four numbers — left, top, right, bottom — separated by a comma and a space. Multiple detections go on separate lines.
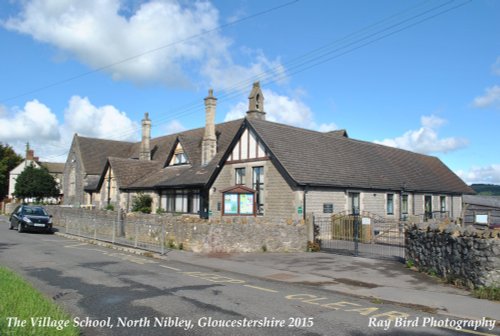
0, 267, 80, 336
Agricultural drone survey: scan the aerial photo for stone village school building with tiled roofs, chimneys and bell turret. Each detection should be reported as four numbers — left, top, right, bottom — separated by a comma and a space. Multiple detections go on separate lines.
61, 83, 474, 220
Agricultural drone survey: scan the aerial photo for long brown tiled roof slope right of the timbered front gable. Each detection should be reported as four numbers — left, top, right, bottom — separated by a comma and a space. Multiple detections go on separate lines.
248, 119, 474, 194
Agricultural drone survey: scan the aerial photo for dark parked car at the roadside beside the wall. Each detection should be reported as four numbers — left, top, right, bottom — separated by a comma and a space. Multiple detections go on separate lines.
9, 205, 52, 233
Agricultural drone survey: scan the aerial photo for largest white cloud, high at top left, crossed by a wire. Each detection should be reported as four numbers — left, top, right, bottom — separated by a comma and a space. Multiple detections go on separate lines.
1, 0, 282, 88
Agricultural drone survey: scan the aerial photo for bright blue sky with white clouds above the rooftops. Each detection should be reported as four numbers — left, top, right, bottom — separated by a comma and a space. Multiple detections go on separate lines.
0, 0, 500, 184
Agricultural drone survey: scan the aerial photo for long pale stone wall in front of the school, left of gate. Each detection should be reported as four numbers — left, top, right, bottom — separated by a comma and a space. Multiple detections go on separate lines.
47, 206, 307, 253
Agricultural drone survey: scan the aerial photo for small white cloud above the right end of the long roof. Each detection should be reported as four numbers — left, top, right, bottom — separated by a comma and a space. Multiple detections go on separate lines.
374, 115, 468, 154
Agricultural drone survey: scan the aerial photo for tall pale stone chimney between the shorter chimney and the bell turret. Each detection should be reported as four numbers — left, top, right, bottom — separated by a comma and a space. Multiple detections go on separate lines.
201, 89, 217, 165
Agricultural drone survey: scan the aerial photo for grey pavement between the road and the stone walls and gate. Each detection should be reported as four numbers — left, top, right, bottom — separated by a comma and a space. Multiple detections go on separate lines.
51, 232, 500, 323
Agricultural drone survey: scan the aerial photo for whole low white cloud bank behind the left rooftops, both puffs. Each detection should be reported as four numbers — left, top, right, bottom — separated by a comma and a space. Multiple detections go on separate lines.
0, 96, 140, 162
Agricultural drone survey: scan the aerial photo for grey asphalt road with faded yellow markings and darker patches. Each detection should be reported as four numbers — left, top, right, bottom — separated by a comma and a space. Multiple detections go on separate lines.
0, 217, 499, 336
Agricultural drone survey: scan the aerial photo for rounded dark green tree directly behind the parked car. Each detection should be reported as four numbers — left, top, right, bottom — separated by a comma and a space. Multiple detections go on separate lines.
14, 164, 59, 201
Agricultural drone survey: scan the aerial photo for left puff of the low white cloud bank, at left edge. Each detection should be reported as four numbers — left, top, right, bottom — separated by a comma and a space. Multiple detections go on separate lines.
0, 99, 60, 143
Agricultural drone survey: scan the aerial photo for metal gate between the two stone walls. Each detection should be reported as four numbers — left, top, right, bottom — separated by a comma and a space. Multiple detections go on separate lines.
314, 211, 405, 262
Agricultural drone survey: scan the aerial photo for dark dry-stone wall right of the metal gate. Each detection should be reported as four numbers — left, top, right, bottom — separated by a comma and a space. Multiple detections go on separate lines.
406, 224, 500, 288
